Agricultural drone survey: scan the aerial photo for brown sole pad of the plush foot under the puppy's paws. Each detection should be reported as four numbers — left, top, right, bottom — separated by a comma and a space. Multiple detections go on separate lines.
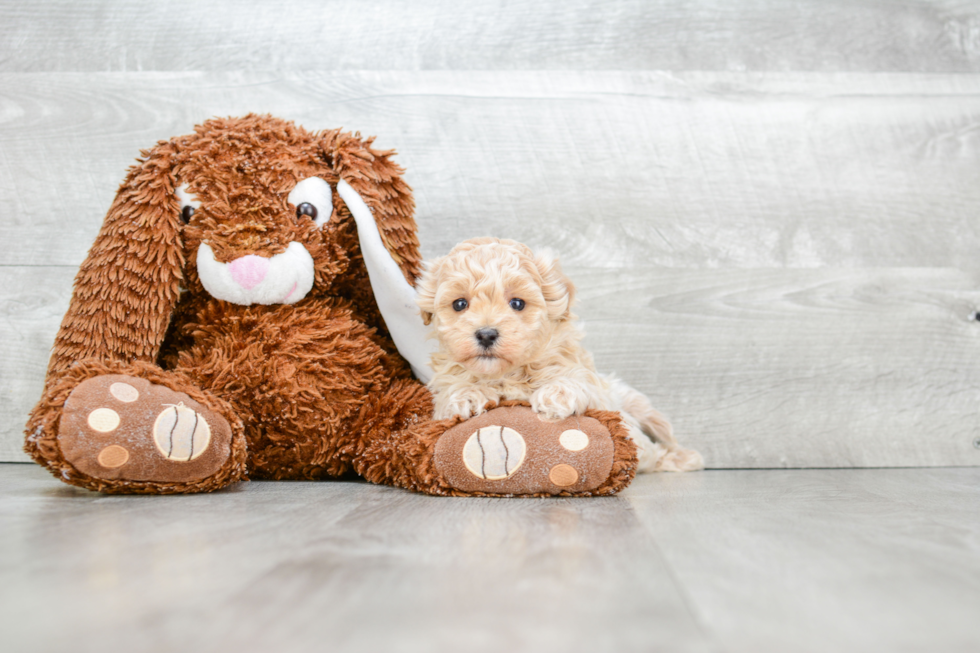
434, 406, 614, 495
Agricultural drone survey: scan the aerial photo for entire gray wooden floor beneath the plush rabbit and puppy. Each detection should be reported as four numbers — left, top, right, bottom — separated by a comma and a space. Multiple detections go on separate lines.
0, 464, 980, 653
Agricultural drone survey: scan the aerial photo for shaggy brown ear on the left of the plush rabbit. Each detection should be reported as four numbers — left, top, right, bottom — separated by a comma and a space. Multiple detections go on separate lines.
48, 141, 184, 378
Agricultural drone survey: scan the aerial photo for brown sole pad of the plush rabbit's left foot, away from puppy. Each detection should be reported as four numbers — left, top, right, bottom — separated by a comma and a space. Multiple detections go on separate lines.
58, 374, 232, 485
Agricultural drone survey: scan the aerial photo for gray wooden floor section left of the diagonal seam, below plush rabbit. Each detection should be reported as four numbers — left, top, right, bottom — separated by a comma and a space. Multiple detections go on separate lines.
0, 465, 710, 653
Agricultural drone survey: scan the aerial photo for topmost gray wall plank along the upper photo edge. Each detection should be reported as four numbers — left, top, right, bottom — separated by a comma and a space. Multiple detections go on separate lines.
0, 0, 980, 72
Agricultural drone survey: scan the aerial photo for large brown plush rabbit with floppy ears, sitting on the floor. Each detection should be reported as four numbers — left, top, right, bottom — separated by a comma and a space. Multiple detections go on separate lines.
25, 115, 636, 495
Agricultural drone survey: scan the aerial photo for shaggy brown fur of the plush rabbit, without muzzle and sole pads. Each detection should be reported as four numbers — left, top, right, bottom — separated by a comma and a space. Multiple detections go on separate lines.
25, 115, 635, 494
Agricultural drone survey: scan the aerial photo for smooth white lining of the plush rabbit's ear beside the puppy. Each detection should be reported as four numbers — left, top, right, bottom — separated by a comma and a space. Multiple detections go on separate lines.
337, 180, 436, 383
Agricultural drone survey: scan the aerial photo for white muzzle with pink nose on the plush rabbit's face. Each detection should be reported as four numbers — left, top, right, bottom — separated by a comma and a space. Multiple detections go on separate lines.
197, 242, 313, 306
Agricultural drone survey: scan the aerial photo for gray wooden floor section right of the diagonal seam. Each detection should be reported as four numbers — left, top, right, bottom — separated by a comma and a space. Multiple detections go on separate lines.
626, 469, 980, 653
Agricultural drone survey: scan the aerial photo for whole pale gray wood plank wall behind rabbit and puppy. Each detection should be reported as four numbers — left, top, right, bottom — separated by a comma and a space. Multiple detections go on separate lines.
0, 0, 980, 467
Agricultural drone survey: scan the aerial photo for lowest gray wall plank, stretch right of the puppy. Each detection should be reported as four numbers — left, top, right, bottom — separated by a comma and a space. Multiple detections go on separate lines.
569, 268, 980, 468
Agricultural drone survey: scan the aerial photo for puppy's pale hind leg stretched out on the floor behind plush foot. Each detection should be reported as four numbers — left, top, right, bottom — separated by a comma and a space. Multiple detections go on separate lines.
610, 379, 704, 472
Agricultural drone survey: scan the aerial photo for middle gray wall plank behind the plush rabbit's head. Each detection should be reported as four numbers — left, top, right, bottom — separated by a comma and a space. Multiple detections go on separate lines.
0, 72, 980, 269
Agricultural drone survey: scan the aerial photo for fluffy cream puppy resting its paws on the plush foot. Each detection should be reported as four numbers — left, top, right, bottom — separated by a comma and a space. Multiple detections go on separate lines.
417, 238, 704, 472
